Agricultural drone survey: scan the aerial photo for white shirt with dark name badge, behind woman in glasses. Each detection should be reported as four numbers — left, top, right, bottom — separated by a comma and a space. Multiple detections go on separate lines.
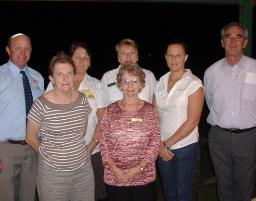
101, 66, 156, 105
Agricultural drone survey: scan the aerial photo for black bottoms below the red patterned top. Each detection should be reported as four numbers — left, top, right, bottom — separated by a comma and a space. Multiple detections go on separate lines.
107, 182, 157, 201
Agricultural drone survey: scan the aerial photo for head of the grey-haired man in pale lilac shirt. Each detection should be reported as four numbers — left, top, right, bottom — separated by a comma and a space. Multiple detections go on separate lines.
221, 26, 248, 56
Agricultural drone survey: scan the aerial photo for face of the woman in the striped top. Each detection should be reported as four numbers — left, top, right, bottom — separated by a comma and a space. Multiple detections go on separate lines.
49, 63, 74, 92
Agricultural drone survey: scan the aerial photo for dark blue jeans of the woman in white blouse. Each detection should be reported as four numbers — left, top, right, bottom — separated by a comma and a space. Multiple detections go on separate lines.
157, 143, 198, 201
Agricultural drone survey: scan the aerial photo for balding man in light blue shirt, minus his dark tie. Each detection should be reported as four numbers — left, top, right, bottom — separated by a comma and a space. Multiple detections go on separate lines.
0, 33, 44, 201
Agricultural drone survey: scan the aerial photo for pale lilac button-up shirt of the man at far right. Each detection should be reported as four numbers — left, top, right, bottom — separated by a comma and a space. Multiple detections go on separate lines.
204, 56, 256, 129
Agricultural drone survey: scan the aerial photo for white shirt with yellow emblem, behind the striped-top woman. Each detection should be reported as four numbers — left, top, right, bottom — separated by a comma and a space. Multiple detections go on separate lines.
46, 74, 106, 154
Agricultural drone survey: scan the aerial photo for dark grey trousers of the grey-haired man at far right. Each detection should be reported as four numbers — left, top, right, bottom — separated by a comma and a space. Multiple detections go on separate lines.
209, 126, 256, 201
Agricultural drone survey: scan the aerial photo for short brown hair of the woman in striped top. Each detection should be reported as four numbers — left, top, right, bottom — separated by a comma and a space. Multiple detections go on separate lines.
49, 52, 76, 76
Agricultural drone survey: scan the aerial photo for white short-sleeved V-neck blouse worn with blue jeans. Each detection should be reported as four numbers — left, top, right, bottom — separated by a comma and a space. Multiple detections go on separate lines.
155, 69, 203, 149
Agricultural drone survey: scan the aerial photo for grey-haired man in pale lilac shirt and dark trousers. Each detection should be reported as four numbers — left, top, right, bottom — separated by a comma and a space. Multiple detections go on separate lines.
204, 22, 256, 201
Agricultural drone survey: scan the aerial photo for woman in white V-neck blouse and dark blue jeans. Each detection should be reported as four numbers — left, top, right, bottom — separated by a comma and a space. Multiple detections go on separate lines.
155, 41, 204, 201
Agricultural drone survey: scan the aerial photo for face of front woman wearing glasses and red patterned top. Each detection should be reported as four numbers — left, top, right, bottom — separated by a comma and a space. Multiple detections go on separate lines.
120, 72, 142, 97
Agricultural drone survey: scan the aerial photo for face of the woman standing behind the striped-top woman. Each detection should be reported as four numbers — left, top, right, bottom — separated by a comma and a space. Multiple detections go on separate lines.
72, 47, 91, 74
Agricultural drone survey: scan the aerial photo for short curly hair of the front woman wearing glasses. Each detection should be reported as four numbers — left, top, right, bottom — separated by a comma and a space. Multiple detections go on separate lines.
116, 64, 146, 89
